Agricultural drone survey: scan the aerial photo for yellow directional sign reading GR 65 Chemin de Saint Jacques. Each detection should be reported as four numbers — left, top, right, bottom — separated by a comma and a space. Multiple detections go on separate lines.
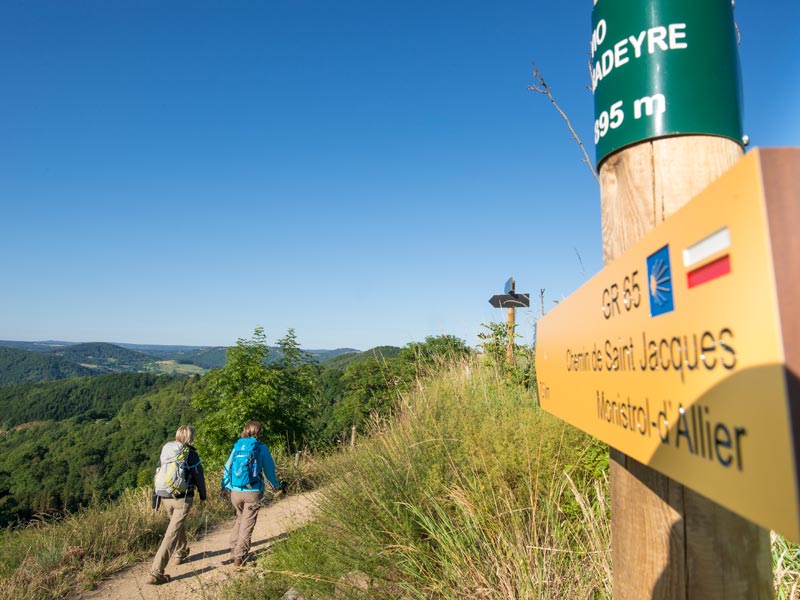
536, 150, 800, 540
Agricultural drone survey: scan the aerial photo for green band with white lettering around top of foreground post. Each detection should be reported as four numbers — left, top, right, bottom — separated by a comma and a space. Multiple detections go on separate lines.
591, 0, 742, 166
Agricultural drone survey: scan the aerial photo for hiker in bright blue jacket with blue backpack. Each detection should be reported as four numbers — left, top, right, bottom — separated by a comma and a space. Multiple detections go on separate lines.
222, 421, 281, 567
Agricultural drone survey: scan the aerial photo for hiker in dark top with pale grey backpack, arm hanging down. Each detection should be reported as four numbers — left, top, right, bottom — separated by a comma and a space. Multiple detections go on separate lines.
147, 425, 206, 585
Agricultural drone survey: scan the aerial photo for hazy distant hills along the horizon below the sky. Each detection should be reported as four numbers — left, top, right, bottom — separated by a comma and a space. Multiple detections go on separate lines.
0, 340, 366, 385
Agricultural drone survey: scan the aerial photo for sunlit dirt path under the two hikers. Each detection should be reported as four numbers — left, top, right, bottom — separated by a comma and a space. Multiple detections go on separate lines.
80, 492, 318, 600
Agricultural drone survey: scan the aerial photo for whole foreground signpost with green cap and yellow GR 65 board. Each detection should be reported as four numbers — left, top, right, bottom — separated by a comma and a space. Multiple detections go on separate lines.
536, 0, 800, 600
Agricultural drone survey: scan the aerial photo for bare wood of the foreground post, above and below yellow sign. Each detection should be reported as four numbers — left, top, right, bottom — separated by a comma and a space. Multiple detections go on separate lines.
600, 136, 773, 600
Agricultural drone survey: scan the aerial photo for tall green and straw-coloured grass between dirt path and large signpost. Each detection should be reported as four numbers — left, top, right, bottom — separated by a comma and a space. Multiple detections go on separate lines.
226, 363, 611, 599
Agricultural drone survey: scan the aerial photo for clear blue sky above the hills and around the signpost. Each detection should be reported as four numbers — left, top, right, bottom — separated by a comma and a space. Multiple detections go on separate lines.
0, 0, 800, 349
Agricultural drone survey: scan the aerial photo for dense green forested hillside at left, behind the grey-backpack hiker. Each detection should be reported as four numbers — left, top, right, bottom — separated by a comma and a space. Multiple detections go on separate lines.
0, 373, 198, 527
